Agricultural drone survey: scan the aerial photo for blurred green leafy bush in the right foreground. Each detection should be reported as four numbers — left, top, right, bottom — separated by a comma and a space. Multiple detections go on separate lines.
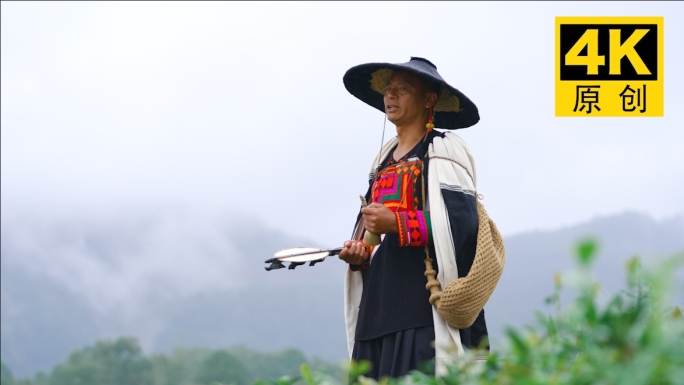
268, 240, 684, 385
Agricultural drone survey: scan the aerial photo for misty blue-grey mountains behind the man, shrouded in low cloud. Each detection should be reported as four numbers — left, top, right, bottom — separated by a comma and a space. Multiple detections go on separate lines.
1, 210, 684, 376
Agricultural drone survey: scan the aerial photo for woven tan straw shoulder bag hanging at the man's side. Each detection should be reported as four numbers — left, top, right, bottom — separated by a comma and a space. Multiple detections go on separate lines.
425, 198, 506, 329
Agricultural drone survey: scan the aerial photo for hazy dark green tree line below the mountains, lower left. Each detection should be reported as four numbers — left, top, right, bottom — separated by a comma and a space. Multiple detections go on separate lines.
0, 337, 341, 385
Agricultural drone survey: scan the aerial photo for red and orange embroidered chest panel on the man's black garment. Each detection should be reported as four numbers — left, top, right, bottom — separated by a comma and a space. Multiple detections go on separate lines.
372, 160, 423, 212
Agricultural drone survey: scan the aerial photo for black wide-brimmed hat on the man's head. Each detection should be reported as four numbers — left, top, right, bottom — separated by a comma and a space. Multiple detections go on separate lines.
343, 57, 480, 130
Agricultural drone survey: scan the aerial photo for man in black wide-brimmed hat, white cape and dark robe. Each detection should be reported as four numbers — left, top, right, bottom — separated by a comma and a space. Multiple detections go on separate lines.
340, 57, 488, 379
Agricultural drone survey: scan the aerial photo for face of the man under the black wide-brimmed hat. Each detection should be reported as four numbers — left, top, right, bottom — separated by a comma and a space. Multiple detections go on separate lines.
384, 71, 428, 126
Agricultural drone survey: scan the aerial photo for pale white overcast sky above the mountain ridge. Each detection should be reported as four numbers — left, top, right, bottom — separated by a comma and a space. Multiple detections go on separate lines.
1, 2, 684, 246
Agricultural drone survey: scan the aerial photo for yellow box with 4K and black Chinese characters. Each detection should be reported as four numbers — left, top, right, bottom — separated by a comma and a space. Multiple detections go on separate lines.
555, 17, 664, 117
